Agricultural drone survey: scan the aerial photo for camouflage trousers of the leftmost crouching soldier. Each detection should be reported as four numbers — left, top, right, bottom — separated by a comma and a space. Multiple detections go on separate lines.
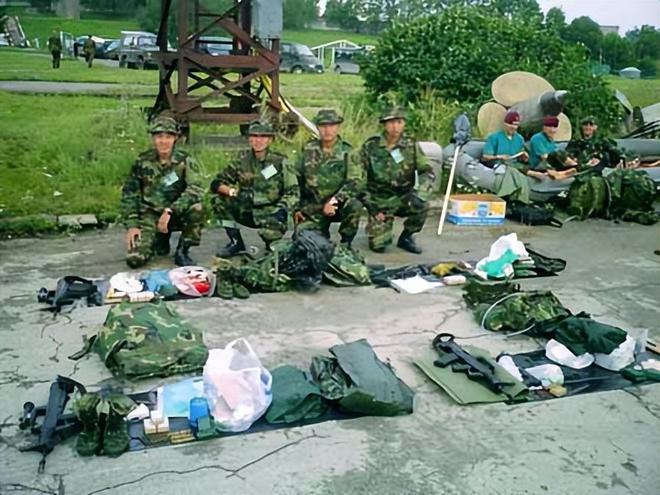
126, 203, 206, 268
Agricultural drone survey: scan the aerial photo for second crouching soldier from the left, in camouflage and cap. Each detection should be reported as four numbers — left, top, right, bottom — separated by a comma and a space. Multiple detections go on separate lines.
211, 122, 298, 258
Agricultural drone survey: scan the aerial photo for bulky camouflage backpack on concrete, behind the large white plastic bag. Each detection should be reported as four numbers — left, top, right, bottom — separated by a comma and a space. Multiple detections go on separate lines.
70, 301, 208, 379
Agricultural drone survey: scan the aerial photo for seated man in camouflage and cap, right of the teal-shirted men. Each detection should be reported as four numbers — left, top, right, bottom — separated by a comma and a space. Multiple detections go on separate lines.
566, 115, 621, 170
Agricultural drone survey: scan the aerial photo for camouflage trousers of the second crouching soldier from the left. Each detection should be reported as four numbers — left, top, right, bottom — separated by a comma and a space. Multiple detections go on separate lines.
213, 196, 287, 244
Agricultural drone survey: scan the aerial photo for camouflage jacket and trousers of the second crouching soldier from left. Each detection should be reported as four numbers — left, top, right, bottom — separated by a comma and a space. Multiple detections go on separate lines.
211, 150, 298, 244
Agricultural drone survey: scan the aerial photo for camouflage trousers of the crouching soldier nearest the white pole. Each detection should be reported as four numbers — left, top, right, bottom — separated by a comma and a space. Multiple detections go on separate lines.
367, 192, 429, 251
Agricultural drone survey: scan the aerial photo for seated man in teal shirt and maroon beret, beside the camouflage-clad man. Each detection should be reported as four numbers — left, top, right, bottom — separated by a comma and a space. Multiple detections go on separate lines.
527, 116, 577, 180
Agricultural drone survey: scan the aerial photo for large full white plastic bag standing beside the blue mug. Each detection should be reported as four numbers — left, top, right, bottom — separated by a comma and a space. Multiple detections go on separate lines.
204, 339, 273, 432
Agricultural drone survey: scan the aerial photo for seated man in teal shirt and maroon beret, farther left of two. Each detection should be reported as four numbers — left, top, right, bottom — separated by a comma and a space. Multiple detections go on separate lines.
481, 111, 529, 169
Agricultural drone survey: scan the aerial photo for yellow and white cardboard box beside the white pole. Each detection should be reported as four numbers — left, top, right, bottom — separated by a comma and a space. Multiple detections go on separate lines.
447, 194, 506, 225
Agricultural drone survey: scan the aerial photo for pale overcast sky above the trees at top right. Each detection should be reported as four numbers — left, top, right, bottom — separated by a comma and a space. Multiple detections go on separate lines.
321, 0, 660, 35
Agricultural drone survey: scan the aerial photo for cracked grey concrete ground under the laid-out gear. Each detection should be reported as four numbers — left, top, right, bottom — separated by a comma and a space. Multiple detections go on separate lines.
0, 221, 660, 495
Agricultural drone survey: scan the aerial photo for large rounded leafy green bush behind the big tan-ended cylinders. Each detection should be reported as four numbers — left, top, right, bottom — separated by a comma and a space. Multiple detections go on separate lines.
361, 6, 618, 132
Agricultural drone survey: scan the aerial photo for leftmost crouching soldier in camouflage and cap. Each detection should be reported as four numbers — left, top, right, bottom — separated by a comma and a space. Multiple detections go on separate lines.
121, 116, 205, 268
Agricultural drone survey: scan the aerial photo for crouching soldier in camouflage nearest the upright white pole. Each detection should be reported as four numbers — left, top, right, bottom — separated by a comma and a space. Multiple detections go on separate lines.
360, 107, 435, 254
